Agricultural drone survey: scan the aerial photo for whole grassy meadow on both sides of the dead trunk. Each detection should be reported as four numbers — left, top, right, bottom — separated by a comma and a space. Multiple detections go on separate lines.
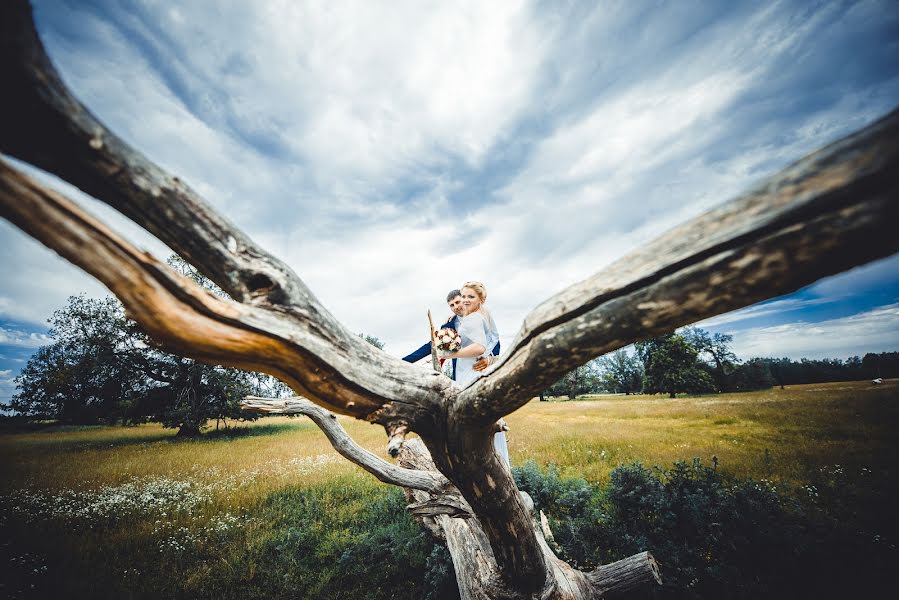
0, 380, 899, 598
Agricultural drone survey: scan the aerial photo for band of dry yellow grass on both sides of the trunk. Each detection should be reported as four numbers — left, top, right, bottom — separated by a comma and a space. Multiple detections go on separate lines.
0, 380, 899, 504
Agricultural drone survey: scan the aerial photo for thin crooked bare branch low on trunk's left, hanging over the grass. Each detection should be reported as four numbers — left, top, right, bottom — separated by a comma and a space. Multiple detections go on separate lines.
240, 396, 450, 494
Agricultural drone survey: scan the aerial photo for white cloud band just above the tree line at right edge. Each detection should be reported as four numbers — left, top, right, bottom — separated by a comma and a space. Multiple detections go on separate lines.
734, 303, 899, 359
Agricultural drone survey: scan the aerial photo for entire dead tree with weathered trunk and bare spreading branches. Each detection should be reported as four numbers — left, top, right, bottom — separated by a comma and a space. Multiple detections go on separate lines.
0, 0, 899, 599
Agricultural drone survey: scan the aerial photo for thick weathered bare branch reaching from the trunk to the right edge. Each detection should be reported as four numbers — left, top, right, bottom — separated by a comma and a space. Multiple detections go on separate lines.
458, 111, 899, 422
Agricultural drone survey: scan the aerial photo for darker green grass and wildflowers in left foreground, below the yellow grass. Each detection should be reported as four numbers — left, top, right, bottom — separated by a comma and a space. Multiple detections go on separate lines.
0, 478, 459, 600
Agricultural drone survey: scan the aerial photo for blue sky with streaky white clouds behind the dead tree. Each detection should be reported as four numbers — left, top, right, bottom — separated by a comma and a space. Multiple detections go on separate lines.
0, 0, 899, 402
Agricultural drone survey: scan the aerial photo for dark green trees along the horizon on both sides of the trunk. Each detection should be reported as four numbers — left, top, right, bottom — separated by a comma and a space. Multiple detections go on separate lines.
8, 276, 899, 426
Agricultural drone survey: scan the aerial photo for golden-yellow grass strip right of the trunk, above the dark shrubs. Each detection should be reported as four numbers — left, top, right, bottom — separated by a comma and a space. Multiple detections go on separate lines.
507, 380, 899, 482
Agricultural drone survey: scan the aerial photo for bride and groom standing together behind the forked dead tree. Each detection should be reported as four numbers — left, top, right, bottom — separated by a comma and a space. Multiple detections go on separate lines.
403, 281, 510, 466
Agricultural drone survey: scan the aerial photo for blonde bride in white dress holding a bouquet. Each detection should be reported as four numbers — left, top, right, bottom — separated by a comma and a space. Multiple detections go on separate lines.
444, 281, 511, 466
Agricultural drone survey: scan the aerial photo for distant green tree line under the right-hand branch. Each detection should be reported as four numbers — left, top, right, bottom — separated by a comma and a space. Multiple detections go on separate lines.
542, 327, 899, 399
